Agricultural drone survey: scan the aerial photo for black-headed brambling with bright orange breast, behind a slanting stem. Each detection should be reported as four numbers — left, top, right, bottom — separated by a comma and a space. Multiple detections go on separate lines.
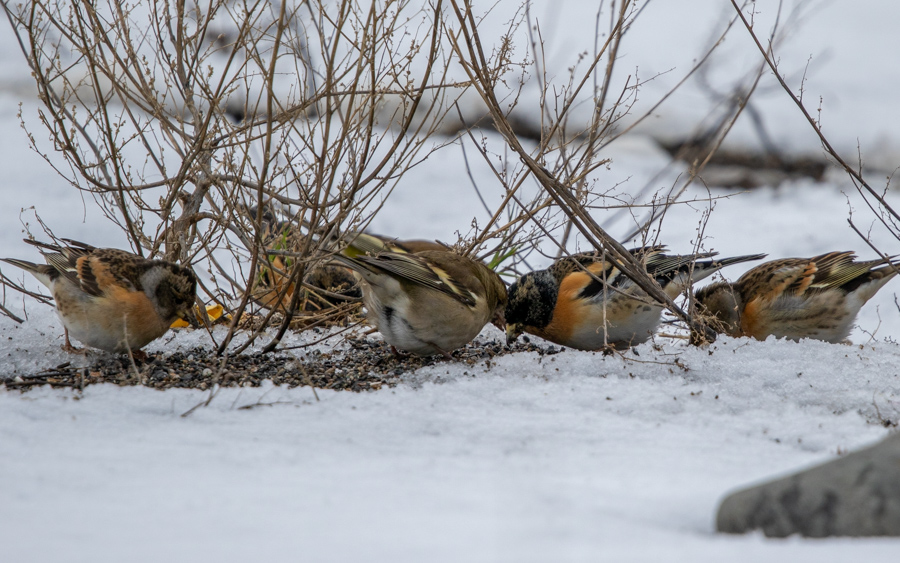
506, 246, 765, 350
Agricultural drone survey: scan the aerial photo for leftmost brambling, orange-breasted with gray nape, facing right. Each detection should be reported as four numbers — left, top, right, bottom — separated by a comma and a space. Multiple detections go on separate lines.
2, 239, 197, 353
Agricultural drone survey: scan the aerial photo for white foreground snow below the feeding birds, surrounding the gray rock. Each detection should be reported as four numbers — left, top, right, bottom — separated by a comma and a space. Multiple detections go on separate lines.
0, 334, 900, 561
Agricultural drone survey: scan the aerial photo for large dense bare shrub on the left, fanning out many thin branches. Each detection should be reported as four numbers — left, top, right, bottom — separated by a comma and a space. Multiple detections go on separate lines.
4, 0, 486, 351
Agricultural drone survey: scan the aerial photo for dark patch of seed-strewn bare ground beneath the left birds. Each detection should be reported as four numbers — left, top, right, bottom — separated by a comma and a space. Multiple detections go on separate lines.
0, 339, 561, 391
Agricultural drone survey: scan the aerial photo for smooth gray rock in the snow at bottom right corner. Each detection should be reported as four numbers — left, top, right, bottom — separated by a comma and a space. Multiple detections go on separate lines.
716, 433, 900, 538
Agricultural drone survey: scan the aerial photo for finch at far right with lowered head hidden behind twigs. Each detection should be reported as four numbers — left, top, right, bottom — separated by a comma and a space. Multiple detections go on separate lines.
696, 252, 900, 343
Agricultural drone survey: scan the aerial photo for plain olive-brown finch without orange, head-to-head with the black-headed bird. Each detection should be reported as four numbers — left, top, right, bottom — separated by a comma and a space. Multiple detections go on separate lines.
336, 246, 506, 358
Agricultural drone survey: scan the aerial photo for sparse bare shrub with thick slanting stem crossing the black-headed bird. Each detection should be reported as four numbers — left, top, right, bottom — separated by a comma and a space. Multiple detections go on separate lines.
440, 0, 784, 346
